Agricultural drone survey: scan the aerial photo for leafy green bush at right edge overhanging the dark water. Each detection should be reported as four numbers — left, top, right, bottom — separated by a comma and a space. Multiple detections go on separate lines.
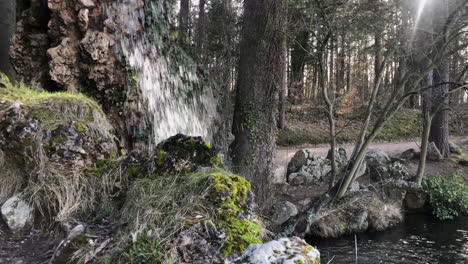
423, 173, 468, 220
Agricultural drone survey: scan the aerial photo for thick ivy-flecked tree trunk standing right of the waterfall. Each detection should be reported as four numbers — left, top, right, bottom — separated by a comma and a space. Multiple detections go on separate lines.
230, 0, 285, 208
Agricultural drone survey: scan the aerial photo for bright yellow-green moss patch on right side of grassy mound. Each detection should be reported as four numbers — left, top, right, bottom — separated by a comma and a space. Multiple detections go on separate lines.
210, 172, 262, 255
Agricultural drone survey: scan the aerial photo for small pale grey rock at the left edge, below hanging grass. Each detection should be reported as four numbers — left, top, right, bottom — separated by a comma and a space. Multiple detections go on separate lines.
1, 195, 33, 232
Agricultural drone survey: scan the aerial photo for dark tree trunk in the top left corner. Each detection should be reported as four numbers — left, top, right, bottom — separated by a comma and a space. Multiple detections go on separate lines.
0, 0, 16, 80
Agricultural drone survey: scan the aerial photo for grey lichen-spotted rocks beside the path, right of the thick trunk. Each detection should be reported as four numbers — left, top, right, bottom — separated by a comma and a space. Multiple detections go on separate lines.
287, 148, 352, 186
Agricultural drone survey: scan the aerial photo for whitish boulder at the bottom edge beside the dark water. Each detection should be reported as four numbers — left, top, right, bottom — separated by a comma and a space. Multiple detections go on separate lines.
234, 237, 320, 264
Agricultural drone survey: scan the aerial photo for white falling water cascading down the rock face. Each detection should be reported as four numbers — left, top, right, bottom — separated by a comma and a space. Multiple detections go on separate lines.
107, 0, 215, 144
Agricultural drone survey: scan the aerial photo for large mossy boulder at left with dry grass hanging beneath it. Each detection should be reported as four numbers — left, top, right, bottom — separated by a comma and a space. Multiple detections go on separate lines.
0, 75, 118, 222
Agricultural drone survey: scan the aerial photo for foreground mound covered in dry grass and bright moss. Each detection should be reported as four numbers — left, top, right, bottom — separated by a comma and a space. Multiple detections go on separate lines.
115, 168, 261, 263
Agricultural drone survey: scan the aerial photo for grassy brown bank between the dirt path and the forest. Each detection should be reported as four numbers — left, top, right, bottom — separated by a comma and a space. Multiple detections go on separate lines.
277, 104, 468, 146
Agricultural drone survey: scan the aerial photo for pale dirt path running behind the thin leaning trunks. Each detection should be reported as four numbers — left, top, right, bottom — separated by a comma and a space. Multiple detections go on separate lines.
275, 137, 468, 166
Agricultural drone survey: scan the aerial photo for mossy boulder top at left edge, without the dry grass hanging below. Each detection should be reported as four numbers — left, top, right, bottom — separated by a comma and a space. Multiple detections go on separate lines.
0, 75, 117, 170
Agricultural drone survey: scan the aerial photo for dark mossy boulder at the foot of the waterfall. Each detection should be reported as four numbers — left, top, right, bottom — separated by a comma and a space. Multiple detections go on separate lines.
154, 134, 220, 174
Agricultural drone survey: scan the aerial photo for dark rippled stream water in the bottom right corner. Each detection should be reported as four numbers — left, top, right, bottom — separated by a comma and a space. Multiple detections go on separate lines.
308, 215, 468, 264
